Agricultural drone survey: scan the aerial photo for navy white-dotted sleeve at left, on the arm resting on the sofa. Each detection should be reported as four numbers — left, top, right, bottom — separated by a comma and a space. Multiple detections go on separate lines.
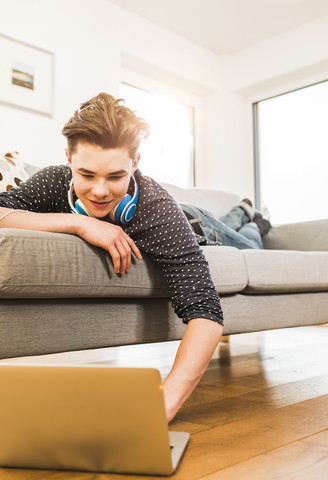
0, 165, 71, 213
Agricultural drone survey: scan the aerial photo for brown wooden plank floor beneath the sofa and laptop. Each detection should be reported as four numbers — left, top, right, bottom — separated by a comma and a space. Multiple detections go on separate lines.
0, 326, 328, 480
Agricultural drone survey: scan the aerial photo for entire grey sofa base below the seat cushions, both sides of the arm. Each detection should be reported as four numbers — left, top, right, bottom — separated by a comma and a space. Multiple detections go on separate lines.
0, 292, 328, 358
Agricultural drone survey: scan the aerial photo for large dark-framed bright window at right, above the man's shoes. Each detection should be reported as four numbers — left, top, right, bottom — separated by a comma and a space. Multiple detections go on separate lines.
254, 82, 328, 224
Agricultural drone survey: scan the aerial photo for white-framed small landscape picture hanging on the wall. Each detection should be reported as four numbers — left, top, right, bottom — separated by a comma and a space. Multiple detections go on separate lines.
0, 35, 54, 116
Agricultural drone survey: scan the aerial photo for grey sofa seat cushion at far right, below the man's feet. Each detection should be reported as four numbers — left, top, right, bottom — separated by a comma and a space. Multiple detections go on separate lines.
242, 250, 328, 293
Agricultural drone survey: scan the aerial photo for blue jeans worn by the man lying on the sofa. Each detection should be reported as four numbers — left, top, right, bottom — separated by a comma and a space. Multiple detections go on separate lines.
181, 204, 263, 249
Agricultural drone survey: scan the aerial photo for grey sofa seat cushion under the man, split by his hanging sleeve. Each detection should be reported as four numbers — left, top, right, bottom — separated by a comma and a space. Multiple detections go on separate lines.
0, 228, 247, 298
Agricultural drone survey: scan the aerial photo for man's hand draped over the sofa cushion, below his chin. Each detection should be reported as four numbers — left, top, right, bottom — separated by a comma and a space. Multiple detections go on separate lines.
77, 217, 142, 275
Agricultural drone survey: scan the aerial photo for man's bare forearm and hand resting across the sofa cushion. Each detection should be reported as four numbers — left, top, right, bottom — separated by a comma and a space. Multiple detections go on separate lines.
0, 207, 142, 275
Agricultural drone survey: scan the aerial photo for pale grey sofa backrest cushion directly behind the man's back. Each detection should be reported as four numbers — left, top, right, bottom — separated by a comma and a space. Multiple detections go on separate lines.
161, 183, 241, 218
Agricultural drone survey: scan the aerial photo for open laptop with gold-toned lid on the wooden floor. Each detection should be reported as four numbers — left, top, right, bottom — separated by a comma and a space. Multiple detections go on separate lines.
0, 364, 189, 475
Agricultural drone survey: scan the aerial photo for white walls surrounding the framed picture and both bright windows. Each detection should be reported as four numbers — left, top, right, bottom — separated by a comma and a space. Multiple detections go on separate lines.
0, 0, 328, 198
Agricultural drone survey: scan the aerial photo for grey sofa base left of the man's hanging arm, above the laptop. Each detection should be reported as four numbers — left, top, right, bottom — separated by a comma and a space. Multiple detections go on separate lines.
0, 298, 186, 358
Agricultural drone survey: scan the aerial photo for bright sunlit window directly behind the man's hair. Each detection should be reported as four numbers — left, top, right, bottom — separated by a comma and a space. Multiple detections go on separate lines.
120, 83, 194, 187
